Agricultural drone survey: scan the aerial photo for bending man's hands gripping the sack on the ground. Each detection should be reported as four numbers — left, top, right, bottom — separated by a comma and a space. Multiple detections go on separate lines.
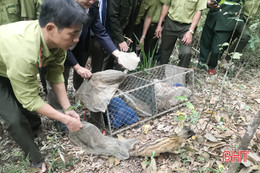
65, 110, 83, 132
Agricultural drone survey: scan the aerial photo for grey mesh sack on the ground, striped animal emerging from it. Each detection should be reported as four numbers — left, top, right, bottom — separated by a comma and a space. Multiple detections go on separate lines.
69, 121, 138, 160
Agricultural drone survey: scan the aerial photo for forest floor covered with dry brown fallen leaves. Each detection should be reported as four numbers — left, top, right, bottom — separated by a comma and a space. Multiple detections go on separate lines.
0, 61, 260, 173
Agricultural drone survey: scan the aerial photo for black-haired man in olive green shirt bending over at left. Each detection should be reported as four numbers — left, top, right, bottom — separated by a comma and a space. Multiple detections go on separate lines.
0, 0, 86, 172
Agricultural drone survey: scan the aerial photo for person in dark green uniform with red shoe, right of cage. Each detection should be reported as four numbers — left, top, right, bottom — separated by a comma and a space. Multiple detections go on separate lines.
198, 0, 244, 75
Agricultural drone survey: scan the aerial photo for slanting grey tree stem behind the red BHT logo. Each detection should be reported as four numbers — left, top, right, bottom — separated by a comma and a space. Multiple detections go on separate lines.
227, 111, 260, 172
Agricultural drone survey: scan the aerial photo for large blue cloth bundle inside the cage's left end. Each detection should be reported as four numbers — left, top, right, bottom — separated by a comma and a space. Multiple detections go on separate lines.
108, 97, 139, 128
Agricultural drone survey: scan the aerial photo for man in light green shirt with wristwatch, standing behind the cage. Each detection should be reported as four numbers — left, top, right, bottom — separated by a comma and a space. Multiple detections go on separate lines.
156, 0, 207, 67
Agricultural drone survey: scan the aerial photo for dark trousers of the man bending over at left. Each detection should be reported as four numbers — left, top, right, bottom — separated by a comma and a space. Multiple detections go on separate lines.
0, 76, 43, 163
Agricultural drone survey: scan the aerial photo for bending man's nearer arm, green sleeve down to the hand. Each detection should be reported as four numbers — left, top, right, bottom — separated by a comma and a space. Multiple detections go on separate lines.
3, 52, 82, 131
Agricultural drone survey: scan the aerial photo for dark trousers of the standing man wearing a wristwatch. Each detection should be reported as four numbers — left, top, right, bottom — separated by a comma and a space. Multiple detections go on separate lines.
160, 17, 191, 67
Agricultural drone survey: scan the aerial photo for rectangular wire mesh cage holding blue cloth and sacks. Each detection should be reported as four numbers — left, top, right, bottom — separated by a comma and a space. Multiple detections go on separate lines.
102, 64, 194, 135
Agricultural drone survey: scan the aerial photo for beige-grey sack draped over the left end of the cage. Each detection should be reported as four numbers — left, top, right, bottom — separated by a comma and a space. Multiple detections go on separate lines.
76, 70, 126, 112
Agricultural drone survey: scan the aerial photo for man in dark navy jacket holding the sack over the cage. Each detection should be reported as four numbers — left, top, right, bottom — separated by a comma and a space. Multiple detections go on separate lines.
65, 0, 119, 90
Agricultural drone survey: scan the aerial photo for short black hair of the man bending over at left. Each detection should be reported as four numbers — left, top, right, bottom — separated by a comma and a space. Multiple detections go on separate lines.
39, 0, 87, 30
